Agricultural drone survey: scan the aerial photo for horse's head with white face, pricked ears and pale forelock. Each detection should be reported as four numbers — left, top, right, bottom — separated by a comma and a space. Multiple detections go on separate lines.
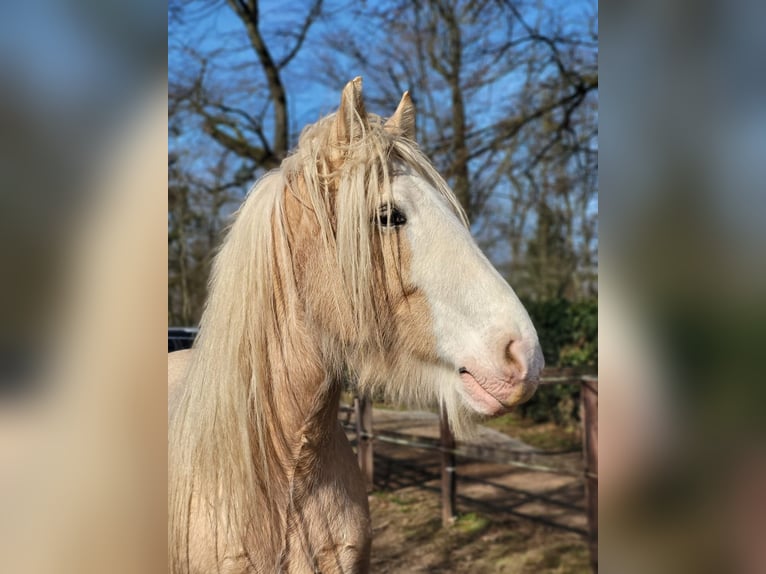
286, 75, 543, 428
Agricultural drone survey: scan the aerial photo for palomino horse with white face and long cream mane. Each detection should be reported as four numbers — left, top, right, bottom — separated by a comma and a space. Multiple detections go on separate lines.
168, 78, 543, 573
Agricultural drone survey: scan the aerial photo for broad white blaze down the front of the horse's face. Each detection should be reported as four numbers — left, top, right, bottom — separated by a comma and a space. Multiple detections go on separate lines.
393, 172, 543, 398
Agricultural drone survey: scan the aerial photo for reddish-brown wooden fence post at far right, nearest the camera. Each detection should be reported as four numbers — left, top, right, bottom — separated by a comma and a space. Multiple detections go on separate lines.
580, 376, 598, 572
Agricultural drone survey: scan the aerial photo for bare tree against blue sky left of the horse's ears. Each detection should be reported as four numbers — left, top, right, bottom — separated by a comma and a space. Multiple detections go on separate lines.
168, 0, 323, 324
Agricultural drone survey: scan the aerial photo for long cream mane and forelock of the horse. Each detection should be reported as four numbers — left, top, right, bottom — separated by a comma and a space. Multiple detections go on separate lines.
168, 111, 467, 569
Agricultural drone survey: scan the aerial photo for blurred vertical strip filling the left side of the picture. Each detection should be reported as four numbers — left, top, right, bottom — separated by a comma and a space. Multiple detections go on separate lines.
0, 0, 167, 573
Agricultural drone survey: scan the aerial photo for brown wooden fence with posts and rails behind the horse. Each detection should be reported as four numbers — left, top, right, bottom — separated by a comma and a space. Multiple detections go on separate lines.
346, 369, 598, 572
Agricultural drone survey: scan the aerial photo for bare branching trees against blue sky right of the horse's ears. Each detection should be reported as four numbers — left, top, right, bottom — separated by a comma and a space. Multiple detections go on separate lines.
323, 0, 598, 297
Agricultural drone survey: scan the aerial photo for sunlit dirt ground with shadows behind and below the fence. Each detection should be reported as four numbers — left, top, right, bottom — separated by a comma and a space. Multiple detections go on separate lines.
349, 409, 590, 574
